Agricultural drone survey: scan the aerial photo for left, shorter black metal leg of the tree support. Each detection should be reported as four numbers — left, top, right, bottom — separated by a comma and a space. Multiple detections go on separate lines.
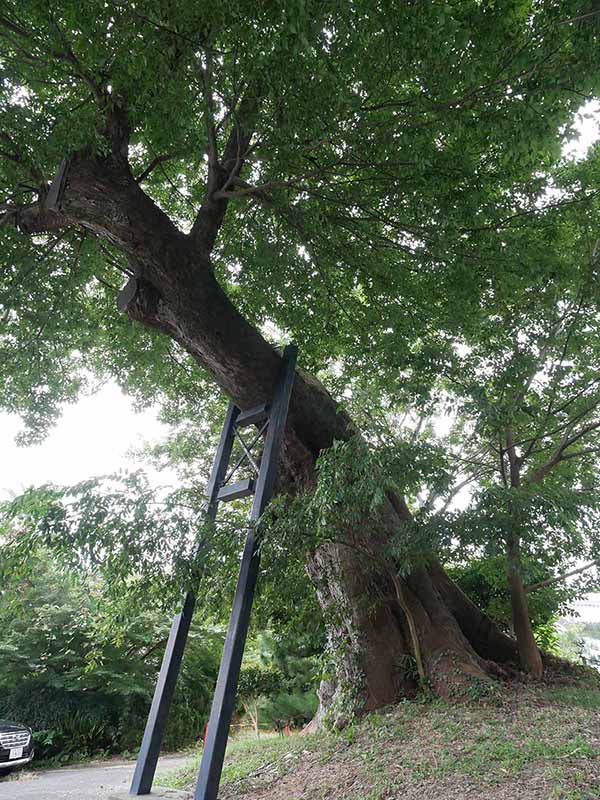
129, 403, 239, 795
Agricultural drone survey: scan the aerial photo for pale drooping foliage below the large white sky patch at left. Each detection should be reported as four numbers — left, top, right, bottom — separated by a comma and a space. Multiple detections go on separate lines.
0, 472, 224, 620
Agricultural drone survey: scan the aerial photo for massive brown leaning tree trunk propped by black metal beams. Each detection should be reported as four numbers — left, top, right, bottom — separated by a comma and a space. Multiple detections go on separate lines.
18, 147, 528, 724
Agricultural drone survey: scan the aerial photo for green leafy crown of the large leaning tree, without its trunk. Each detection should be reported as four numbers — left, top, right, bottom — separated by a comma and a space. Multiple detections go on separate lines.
0, 0, 598, 436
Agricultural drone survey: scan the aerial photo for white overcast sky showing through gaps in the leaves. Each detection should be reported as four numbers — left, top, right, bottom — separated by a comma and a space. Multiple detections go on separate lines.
0, 101, 600, 500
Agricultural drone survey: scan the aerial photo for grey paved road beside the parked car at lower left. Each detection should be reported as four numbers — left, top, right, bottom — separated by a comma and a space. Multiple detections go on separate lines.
0, 756, 190, 800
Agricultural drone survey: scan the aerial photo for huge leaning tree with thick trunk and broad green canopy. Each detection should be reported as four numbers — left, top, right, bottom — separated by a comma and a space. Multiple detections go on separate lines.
0, 0, 599, 713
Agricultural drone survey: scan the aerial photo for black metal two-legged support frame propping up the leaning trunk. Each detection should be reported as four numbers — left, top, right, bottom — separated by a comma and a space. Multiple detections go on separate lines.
129, 345, 298, 800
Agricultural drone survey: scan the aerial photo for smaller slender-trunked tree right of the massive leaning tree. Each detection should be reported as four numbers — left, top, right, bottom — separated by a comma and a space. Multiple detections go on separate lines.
428, 191, 600, 677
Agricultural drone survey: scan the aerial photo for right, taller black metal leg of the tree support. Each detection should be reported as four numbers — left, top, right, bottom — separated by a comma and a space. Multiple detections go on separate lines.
194, 345, 298, 800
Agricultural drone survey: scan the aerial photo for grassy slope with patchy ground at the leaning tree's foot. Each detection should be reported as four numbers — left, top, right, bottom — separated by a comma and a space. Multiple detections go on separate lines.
158, 686, 600, 800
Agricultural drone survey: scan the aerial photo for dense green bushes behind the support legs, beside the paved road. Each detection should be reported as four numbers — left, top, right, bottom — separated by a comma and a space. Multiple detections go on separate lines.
0, 536, 324, 760
